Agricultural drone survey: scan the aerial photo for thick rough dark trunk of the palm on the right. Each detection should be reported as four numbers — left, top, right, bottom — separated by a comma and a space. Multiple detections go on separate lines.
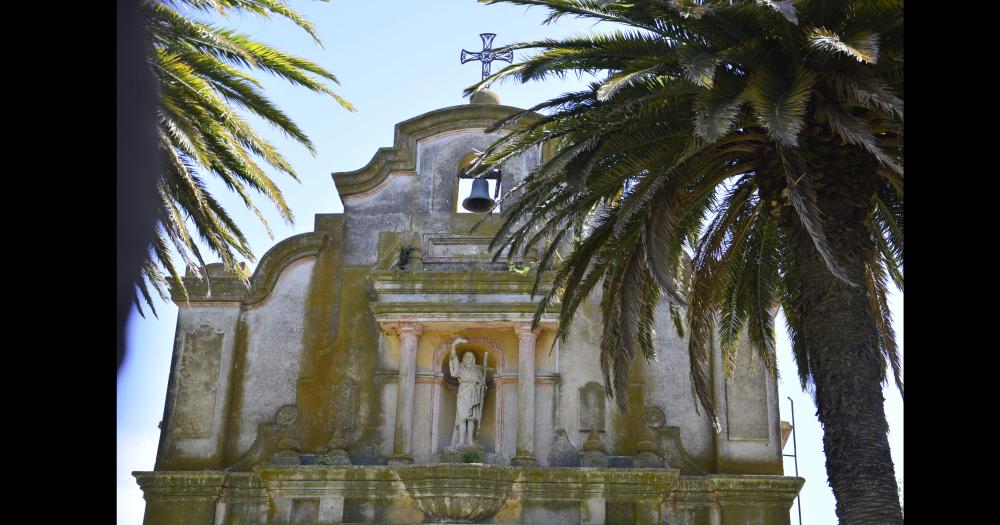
786, 157, 903, 525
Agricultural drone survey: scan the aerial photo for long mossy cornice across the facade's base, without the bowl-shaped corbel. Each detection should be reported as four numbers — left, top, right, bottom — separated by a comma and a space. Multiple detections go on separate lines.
132, 464, 805, 508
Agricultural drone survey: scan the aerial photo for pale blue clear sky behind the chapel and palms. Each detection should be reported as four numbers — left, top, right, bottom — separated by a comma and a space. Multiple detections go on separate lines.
117, 0, 903, 525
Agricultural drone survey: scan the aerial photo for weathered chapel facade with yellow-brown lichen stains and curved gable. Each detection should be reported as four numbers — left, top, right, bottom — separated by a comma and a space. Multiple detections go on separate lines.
135, 93, 804, 525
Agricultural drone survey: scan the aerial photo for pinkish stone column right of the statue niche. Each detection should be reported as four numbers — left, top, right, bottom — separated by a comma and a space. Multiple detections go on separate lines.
510, 323, 538, 466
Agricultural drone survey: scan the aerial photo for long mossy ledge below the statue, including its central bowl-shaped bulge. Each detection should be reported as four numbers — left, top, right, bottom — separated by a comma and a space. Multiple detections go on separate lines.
133, 464, 805, 523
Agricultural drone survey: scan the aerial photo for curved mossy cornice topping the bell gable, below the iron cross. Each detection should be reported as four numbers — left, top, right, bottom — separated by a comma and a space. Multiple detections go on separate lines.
332, 104, 538, 201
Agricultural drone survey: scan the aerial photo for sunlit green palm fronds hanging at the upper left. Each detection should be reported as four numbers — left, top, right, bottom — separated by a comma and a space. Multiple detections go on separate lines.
135, 0, 353, 315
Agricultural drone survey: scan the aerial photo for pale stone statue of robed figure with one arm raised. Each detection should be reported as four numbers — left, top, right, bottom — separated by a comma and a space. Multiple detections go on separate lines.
448, 337, 489, 448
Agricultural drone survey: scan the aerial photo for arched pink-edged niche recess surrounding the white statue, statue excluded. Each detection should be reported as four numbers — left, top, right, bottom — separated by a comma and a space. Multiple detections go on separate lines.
430, 336, 504, 454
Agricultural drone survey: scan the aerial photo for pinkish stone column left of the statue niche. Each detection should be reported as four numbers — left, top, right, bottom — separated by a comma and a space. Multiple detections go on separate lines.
388, 323, 423, 465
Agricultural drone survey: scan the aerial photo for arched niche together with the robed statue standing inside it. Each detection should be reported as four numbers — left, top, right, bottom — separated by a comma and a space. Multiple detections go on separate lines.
439, 337, 496, 453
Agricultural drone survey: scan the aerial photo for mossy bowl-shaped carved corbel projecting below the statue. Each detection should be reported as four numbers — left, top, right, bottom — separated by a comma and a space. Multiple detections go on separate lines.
397, 465, 519, 523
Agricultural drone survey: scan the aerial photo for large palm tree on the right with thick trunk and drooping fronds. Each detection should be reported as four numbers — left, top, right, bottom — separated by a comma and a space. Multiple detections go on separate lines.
469, 0, 903, 524
